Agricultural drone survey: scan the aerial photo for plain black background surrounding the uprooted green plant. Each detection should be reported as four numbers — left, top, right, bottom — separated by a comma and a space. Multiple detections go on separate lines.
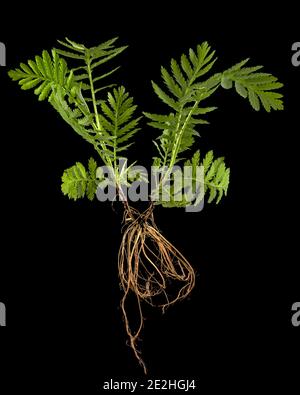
0, 2, 300, 394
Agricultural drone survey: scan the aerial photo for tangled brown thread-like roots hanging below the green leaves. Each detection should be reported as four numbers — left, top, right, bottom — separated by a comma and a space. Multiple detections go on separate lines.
118, 204, 195, 374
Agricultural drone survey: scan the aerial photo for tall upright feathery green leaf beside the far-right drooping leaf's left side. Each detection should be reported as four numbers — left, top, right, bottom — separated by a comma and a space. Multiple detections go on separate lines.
149, 42, 219, 167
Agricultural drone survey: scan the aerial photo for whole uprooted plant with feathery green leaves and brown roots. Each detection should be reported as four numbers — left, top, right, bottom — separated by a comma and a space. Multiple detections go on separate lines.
9, 38, 283, 373
